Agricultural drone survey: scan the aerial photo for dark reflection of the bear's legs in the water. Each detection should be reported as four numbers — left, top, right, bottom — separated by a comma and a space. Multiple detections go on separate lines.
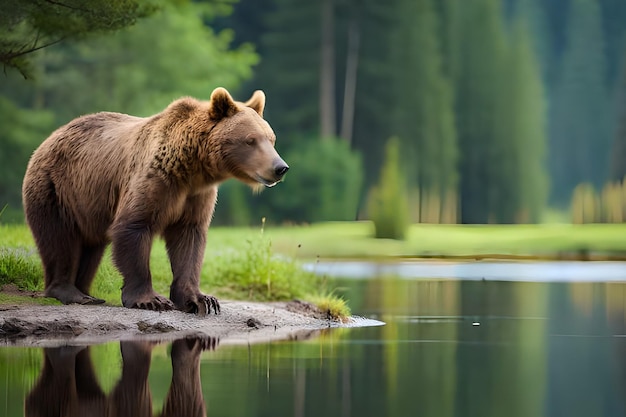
25, 337, 218, 417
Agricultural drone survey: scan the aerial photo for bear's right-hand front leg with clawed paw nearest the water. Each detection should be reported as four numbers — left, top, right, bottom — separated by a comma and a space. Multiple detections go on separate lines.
163, 222, 220, 316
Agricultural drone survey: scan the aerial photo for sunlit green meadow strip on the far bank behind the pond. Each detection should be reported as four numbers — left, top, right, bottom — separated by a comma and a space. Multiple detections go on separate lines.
258, 222, 626, 259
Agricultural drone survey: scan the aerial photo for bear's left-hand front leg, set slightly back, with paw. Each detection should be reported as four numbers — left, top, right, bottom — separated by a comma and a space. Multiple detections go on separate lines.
112, 217, 174, 311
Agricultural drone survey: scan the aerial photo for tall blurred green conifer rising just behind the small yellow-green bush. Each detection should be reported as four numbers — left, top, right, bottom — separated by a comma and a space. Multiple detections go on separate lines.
392, 0, 458, 221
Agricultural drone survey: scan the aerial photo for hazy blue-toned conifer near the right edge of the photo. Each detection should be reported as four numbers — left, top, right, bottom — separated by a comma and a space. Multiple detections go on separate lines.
549, 0, 611, 204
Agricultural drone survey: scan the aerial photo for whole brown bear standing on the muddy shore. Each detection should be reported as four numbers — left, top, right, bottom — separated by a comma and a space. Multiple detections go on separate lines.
22, 88, 289, 315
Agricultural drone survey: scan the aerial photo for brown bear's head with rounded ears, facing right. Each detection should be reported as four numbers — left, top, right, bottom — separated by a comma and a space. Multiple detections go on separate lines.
209, 87, 289, 188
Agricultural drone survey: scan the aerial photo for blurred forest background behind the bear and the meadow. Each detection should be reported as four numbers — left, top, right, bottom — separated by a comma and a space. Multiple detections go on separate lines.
0, 0, 626, 224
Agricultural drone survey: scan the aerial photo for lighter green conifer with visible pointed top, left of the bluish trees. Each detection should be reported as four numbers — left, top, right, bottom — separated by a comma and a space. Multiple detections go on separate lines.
494, 14, 548, 223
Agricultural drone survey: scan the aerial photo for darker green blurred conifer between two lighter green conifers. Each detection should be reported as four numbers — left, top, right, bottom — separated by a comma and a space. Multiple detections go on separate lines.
455, 0, 506, 223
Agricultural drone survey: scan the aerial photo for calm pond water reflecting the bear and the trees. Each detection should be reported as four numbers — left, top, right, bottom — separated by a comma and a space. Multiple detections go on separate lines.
0, 263, 626, 417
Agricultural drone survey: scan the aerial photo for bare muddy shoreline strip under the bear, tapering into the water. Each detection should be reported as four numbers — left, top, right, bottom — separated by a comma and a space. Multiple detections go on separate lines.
0, 301, 366, 347
